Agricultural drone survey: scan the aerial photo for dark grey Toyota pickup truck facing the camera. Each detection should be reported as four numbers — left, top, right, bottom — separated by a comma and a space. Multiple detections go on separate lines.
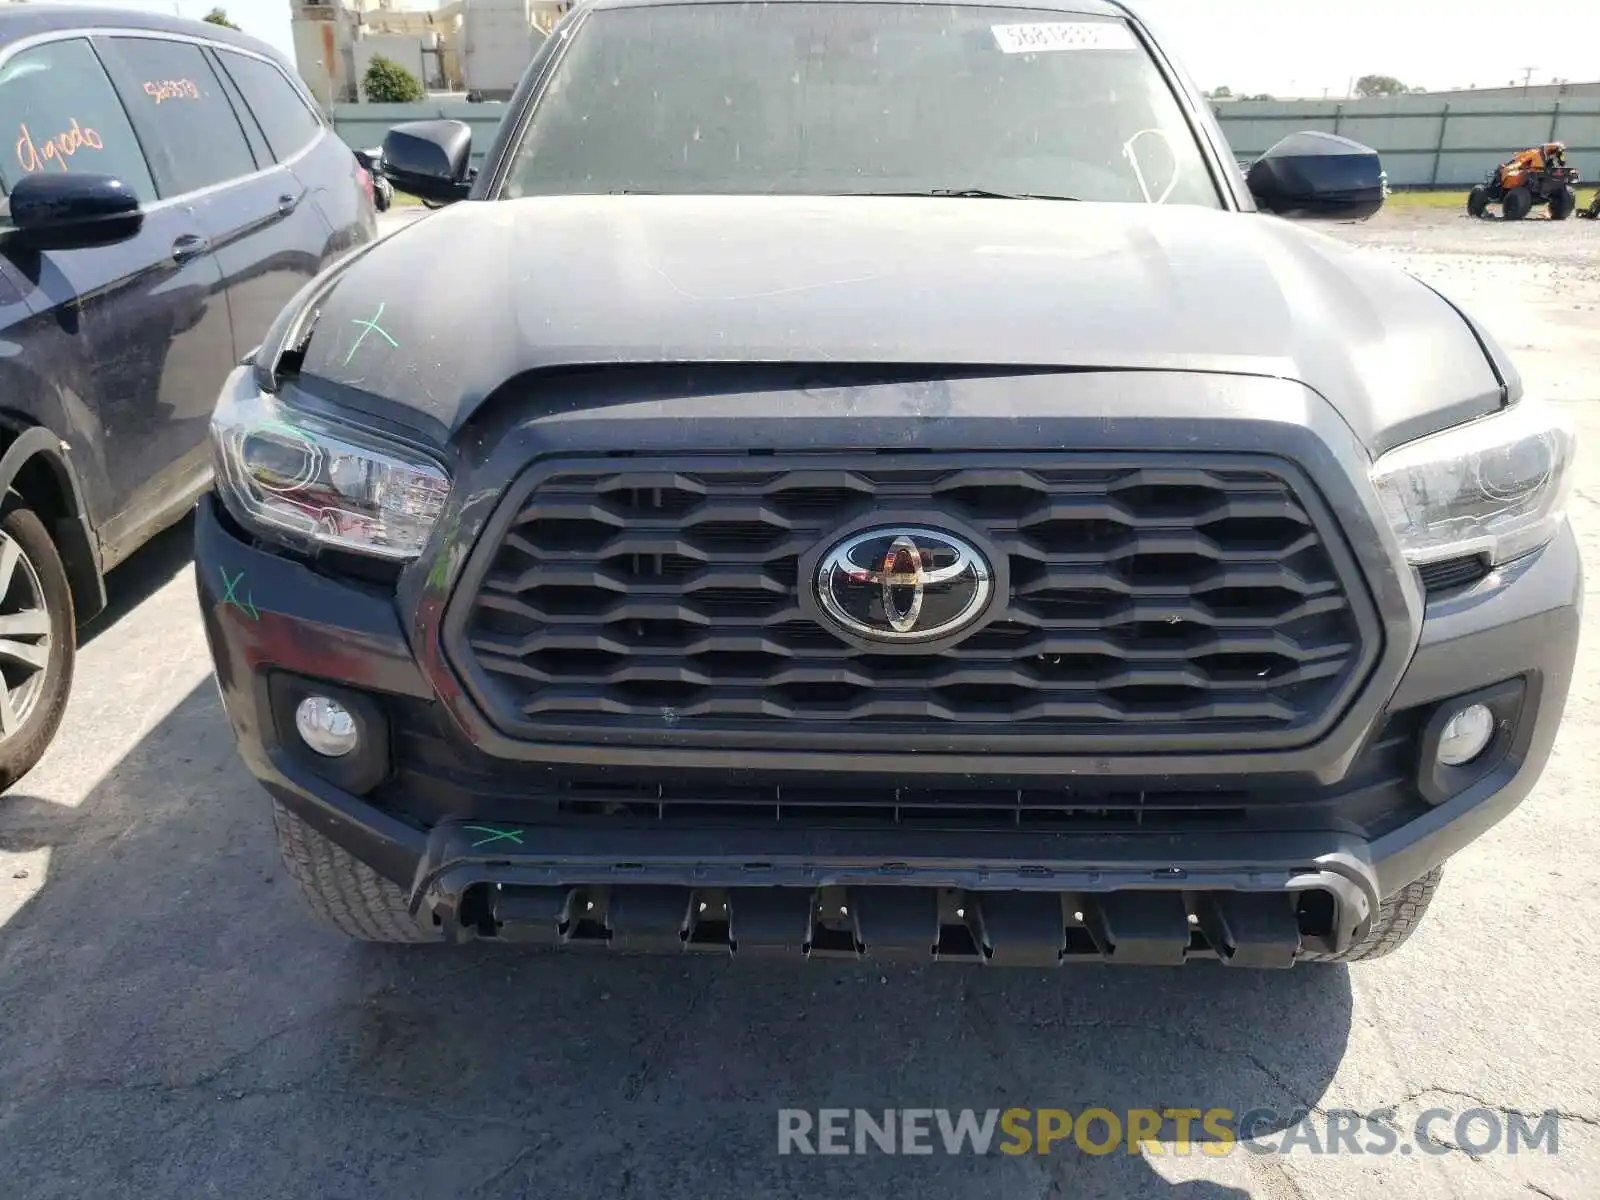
197, 0, 1582, 966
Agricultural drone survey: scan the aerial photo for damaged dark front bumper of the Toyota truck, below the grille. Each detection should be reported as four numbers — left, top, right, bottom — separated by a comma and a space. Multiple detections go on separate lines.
195, 473, 1582, 966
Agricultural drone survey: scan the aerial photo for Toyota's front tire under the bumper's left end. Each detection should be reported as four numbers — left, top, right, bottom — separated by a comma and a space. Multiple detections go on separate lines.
272, 800, 443, 942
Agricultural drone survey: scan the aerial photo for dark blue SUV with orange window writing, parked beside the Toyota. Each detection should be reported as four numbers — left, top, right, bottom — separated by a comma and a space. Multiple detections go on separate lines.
0, 5, 376, 787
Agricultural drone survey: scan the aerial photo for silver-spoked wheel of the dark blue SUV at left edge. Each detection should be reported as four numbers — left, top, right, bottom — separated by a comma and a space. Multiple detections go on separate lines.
0, 504, 78, 790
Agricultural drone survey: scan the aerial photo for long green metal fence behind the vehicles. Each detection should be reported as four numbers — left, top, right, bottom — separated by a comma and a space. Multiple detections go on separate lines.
333, 96, 1600, 187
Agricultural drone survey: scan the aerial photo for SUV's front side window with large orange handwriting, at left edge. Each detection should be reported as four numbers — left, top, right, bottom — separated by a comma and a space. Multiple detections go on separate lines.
0, 38, 155, 200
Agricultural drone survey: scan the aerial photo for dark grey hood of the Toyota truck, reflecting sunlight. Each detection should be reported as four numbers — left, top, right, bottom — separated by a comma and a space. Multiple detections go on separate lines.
301, 197, 1518, 453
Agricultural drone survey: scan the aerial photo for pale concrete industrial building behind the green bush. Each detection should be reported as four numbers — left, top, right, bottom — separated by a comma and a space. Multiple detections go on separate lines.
290, 0, 570, 106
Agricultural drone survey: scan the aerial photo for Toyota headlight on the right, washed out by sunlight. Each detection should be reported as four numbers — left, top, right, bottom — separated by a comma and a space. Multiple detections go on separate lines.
1373, 400, 1574, 563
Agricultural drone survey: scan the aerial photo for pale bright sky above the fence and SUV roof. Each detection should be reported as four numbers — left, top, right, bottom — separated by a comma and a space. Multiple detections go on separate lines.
68, 0, 1600, 96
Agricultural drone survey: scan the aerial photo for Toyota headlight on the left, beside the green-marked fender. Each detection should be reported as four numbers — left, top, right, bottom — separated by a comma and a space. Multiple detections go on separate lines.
211, 370, 450, 560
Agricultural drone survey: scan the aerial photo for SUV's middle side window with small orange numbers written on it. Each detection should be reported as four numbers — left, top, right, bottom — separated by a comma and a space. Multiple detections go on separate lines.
101, 37, 256, 195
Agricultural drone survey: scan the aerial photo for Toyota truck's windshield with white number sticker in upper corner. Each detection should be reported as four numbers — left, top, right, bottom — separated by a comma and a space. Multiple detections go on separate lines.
501, 2, 1221, 208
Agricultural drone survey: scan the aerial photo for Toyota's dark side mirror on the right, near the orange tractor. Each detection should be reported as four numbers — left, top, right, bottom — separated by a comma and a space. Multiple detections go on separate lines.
1245, 133, 1386, 221
